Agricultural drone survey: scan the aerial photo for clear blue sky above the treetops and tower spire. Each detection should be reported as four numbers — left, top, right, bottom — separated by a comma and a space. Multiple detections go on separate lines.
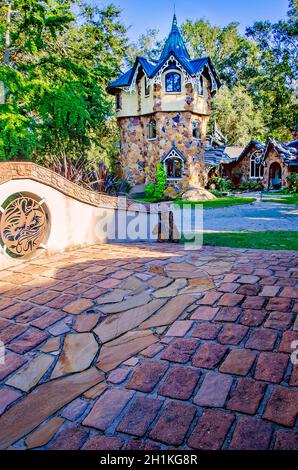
105, 0, 288, 41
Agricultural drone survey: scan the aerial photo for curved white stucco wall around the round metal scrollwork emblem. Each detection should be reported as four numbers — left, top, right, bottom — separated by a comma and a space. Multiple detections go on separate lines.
0, 179, 157, 270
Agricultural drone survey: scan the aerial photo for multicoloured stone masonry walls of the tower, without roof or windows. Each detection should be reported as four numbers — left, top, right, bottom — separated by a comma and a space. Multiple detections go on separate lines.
118, 81, 211, 196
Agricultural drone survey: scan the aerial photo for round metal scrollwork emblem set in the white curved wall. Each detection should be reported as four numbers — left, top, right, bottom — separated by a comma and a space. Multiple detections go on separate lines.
0, 195, 48, 257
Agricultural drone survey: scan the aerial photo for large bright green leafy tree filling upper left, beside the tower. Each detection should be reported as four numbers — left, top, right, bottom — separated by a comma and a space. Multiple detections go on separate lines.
0, 0, 126, 160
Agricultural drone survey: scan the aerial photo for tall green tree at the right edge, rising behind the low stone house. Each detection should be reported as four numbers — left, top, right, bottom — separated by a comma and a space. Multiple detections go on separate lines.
246, 0, 298, 140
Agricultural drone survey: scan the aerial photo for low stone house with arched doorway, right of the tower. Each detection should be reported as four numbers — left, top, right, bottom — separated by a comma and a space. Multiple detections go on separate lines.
222, 137, 298, 190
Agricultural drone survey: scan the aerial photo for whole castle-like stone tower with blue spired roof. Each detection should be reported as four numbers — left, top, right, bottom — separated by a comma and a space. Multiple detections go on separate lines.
108, 15, 220, 195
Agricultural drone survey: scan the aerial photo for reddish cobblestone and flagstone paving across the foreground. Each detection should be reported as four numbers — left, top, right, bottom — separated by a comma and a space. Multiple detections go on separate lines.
0, 244, 298, 450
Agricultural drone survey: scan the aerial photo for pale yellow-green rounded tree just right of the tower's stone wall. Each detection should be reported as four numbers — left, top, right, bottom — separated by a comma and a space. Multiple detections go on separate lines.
209, 85, 265, 146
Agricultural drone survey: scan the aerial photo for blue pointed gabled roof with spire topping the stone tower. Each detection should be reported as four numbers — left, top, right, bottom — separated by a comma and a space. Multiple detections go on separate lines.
108, 15, 220, 94
